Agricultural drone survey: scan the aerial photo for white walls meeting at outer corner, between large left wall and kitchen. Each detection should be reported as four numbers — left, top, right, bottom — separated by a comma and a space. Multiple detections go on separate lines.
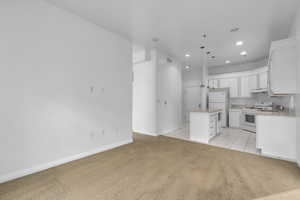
132, 49, 183, 136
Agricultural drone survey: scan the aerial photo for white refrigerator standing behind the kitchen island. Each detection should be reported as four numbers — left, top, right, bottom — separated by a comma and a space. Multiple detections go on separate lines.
208, 88, 229, 127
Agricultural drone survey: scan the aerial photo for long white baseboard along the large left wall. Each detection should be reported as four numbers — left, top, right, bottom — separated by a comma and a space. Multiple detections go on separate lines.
0, 139, 133, 183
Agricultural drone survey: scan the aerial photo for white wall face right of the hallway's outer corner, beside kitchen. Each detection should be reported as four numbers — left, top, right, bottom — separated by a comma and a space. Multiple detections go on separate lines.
157, 52, 183, 134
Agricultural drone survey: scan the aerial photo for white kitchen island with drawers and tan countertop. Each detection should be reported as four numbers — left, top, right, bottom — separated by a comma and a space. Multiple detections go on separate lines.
190, 110, 222, 144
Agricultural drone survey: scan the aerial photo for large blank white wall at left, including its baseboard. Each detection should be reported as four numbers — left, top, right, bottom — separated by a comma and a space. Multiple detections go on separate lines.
0, 0, 132, 182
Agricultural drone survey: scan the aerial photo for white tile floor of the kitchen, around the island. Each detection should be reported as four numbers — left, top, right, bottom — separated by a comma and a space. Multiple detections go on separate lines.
165, 125, 260, 154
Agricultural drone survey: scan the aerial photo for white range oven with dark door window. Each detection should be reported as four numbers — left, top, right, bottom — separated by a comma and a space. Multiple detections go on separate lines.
241, 108, 256, 133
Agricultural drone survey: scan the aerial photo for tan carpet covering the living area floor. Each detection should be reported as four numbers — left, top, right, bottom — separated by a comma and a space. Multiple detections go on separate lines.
0, 135, 300, 200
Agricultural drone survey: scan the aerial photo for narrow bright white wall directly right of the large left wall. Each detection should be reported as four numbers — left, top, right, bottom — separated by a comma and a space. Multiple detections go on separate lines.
132, 51, 157, 136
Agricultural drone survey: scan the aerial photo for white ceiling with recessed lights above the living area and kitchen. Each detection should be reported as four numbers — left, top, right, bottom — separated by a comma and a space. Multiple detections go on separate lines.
50, 0, 300, 66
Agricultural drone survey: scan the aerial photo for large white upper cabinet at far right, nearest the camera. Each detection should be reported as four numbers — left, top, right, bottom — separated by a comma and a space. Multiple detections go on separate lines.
269, 39, 297, 95
